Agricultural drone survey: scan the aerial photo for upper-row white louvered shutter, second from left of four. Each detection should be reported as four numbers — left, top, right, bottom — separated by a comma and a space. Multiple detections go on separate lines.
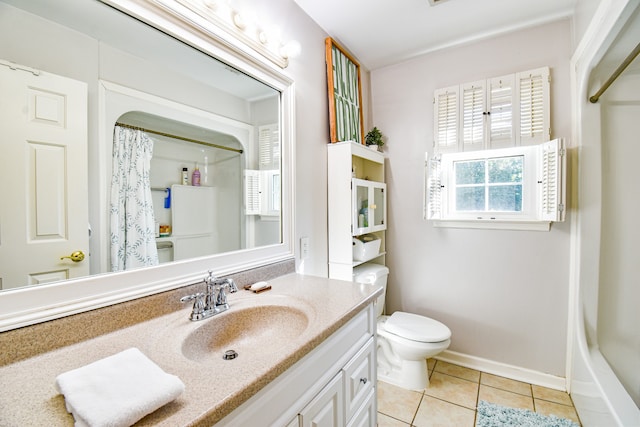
462, 81, 486, 151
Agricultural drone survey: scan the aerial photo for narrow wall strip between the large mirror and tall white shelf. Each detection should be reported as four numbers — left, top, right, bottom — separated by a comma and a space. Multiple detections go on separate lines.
245, 0, 366, 276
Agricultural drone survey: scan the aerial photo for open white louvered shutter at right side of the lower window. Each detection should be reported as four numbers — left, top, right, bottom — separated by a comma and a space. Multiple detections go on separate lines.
538, 139, 566, 221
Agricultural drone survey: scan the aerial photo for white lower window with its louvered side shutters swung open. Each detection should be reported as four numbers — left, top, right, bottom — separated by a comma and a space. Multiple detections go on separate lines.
425, 139, 565, 230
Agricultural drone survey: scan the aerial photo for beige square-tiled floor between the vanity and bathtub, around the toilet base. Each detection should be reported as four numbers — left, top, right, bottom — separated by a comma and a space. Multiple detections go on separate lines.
378, 359, 580, 427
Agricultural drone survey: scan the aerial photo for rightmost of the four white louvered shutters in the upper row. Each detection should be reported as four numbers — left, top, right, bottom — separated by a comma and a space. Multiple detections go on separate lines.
516, 67, 551, 145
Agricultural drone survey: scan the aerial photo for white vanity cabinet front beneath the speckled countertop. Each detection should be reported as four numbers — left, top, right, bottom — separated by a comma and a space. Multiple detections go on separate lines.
216, 304, 377, 427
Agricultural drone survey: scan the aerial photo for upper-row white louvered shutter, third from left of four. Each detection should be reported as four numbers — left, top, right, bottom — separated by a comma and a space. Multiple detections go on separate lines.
488, 75, 516, 148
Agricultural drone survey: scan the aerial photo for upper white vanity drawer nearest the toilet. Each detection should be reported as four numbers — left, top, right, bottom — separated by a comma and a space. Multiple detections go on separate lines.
342, 337, 376, 423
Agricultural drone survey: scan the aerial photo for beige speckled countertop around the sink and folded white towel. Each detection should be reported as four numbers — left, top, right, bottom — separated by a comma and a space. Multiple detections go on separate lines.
0, 274, 382, 427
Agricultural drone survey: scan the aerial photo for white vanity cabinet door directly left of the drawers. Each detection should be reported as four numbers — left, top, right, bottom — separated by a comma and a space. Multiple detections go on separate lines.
299, 372, 344, 427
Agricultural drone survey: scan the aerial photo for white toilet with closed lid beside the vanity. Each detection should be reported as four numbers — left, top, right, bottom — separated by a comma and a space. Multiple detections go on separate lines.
353, 263, 451, 390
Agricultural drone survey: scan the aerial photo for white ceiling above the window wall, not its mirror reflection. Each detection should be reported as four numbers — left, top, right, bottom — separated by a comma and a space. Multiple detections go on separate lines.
295, 0, 578, 70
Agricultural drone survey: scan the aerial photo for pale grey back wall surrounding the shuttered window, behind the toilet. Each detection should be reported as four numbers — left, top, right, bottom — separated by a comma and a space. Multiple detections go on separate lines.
371, 20, 571, 376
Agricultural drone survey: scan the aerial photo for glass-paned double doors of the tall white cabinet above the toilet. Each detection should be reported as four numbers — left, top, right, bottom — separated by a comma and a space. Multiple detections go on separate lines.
351, 178, 387, 236
